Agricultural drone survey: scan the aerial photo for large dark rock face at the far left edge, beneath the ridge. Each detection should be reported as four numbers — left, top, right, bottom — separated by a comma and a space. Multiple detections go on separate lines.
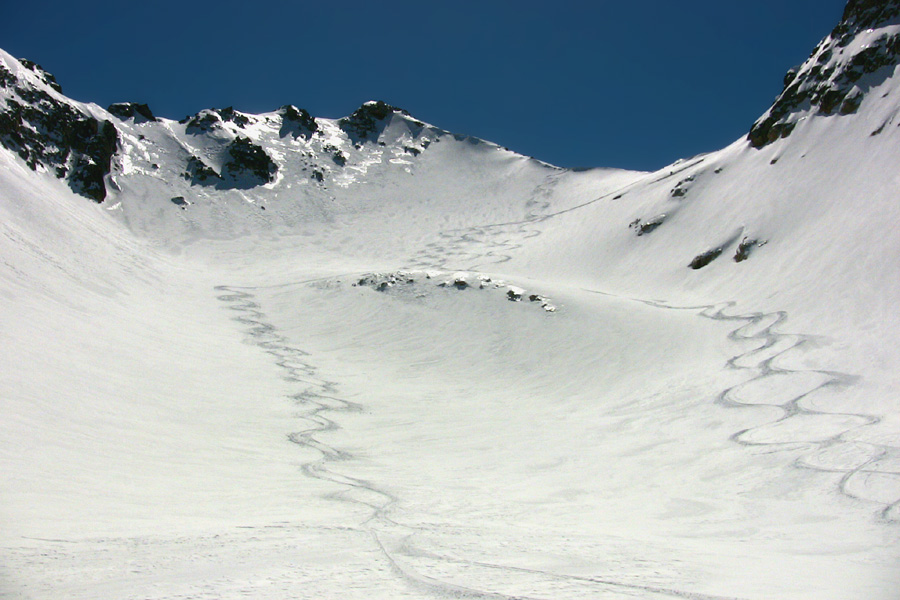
0, 61, 119, 202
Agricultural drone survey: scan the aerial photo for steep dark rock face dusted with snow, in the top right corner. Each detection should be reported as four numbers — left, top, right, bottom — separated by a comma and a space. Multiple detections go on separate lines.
747, 0, 900, 148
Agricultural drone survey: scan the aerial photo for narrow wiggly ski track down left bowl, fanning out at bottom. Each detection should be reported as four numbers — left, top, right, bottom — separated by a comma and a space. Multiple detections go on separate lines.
214, 285, 752, 600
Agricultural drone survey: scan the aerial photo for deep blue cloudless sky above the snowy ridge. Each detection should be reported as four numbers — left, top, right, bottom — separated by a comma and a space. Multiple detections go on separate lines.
0, 0, 845, 169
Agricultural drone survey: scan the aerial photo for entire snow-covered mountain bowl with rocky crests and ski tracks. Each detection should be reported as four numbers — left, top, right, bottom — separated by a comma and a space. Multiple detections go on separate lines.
0, 0, 900, 600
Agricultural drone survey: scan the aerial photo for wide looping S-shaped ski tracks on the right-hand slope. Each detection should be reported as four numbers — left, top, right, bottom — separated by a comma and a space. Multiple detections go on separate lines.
652, 300, 900, 523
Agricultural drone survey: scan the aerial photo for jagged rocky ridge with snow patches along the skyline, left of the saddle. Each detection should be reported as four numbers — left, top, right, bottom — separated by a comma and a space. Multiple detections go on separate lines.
0, 43, 536, 202
